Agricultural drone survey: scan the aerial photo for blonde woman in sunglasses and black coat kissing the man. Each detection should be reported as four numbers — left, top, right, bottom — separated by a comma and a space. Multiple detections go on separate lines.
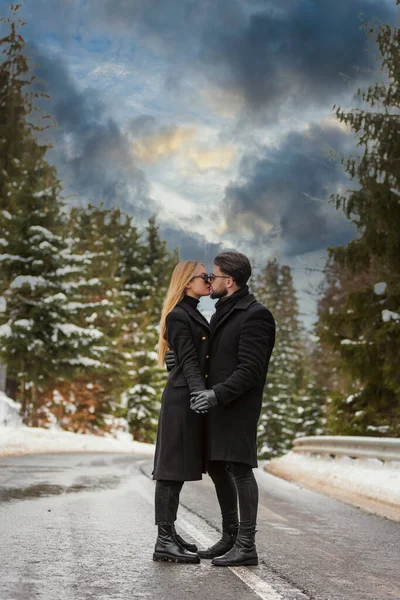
153, 260, 210, 563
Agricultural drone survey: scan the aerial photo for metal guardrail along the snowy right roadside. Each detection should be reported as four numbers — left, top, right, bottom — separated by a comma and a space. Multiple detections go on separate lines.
292, 435, 400, 462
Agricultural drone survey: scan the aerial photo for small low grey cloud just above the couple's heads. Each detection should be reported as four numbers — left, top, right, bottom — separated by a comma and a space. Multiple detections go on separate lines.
160, 225, 225, 265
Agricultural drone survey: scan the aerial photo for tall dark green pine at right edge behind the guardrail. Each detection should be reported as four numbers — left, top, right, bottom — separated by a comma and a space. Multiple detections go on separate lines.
319, 9, 400, 436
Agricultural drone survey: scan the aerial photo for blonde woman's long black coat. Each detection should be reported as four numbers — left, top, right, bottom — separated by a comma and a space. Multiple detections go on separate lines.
153, 301, 210, 481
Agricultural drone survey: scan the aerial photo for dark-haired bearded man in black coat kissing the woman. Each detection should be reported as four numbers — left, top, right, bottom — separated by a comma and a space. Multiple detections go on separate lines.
167, 252, 275, 566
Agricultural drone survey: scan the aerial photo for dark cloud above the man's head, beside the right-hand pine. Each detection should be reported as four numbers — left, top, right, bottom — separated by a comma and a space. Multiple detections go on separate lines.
224, 120, 354, 255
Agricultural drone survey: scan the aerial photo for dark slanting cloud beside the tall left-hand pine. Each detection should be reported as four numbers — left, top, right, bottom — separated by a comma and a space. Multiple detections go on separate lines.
32, 52, 152, 216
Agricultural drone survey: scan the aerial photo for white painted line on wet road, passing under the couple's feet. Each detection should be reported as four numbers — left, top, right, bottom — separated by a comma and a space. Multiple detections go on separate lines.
135, 468, 284, 600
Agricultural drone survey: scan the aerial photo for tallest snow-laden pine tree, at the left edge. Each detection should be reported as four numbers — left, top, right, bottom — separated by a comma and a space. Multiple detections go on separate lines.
0, 6, 107, 425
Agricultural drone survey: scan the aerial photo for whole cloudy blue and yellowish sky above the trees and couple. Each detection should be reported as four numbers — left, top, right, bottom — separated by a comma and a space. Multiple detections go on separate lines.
0, 0, 398, 328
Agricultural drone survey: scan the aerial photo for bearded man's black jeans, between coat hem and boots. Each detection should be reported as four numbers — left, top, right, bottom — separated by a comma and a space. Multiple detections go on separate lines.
207, 460, 258, 531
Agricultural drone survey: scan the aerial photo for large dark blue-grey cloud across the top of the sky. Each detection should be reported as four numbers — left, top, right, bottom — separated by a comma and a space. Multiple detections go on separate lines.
90, 0, 396, 121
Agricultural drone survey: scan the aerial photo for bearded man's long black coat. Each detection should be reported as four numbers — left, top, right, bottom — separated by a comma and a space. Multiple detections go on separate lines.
207, 294, 275, 467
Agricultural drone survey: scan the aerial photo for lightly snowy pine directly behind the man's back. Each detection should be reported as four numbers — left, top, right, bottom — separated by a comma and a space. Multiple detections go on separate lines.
252, 259, 320, 458
